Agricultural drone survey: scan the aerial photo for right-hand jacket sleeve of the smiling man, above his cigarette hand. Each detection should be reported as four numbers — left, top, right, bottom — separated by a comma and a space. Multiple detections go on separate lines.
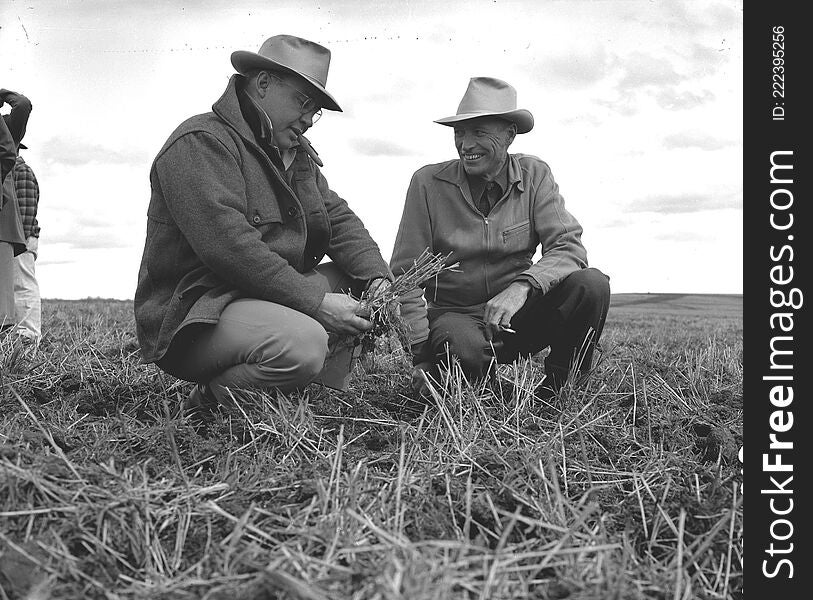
522, 161, 587, 294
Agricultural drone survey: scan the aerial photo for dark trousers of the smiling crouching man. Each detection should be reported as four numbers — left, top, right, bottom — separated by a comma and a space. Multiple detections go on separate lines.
429, 268, 610, 387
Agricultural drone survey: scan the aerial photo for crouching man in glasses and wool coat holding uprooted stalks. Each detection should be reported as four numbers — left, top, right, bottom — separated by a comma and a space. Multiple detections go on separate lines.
135, 35, 392, 405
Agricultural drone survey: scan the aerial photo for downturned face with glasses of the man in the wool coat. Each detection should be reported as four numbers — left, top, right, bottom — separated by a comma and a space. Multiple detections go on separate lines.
251, 71, 320, 152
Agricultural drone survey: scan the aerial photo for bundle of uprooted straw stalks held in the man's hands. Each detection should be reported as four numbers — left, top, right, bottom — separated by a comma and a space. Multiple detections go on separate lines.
353, 249, 459, 348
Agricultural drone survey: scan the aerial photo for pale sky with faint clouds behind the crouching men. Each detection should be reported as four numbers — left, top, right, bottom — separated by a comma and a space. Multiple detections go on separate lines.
0, 0, 743, 299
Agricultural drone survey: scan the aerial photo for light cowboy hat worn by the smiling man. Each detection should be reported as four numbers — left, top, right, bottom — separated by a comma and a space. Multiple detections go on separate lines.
435, 77, 534, 133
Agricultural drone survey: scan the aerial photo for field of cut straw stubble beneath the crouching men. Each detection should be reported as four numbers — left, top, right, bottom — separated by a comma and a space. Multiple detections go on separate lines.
0, 295, 743, 600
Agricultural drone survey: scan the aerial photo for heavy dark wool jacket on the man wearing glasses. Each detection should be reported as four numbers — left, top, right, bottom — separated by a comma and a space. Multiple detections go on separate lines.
134, 75, 391, 362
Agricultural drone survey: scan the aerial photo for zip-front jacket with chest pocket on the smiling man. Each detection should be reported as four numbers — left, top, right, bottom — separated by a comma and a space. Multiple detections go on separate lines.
390, 154, 587, 345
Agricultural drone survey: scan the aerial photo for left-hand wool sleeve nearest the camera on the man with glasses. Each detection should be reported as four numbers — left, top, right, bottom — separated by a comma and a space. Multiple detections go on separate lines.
154, 132, 325, 315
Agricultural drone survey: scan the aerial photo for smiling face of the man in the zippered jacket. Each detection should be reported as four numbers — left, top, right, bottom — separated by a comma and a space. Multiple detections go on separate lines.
454, 117, 517, 181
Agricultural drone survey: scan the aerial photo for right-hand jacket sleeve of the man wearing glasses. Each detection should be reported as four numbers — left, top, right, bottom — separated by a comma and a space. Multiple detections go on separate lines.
313, 164, 392, 282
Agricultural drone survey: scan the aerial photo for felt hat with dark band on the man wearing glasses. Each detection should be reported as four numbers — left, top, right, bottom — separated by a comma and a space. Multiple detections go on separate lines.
231, 35, 342, 111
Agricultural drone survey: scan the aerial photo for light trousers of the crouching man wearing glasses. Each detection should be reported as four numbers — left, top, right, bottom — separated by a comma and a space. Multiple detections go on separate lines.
158, 263, 352, 401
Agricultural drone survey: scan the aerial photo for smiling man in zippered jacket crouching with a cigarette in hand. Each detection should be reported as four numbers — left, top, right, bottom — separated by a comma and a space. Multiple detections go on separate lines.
390, 77, 610, 398
